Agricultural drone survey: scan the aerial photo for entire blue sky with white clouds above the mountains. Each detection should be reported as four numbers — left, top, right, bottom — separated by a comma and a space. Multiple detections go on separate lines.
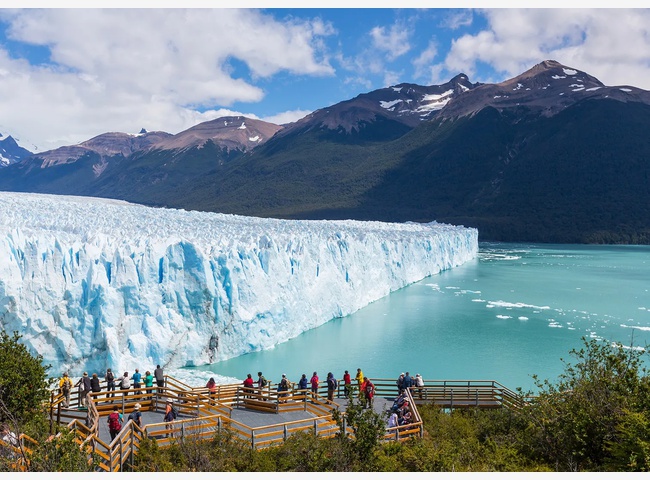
0, 0, 650, 151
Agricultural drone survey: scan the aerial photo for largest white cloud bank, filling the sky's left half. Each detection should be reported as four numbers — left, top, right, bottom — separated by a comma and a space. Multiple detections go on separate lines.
0, 9, 334, 150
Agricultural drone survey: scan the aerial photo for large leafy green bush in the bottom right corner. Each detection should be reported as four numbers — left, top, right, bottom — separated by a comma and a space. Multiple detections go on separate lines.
521, 339, 650, 471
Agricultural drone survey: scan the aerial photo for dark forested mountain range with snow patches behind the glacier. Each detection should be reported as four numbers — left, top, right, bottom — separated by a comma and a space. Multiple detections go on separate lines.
0, 60, 650, 244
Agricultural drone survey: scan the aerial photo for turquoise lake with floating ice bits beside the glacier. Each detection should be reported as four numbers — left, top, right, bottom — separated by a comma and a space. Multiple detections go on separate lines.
187, 243, 650, 390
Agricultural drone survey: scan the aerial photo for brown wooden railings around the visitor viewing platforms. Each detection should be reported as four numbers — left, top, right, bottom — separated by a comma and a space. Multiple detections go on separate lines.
31, 376, 525, 472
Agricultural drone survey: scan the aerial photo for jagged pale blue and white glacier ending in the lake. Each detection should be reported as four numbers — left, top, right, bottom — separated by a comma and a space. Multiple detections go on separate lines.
0, 192, 478, 375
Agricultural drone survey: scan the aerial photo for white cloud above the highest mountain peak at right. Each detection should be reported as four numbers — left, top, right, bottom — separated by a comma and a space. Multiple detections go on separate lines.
443, 9, 650, 89
